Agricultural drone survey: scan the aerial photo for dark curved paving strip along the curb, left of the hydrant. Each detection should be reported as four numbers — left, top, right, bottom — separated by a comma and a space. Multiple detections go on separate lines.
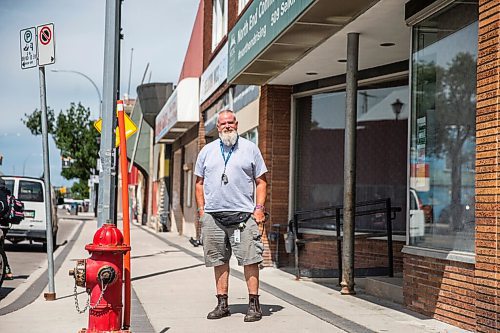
0, 221, 85, 316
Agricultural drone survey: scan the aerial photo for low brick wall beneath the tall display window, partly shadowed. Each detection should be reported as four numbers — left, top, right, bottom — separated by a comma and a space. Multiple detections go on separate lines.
403, 254, 476, 331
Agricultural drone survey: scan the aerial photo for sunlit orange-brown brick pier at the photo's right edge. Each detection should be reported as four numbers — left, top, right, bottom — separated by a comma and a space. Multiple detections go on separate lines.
475, 0, 500, 332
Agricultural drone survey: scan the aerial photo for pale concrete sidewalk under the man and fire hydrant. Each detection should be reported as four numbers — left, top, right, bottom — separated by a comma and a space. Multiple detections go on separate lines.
0, 215, 467, 333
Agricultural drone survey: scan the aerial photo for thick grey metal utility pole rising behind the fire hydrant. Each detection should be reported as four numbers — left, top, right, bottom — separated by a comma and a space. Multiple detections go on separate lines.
97, 0, 121, 227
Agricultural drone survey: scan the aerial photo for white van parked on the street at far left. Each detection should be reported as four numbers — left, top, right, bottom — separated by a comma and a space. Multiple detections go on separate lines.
2, 176, 58, 249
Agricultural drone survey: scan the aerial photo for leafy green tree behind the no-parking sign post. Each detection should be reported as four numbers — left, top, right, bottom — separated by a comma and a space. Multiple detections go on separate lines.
22, 103, 99, 184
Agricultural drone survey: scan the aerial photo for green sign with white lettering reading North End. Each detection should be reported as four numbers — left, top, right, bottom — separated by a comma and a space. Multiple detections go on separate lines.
228, 0, 315, 81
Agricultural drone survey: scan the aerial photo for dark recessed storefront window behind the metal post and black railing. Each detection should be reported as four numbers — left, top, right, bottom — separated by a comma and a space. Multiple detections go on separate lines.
295, 84, 409, 233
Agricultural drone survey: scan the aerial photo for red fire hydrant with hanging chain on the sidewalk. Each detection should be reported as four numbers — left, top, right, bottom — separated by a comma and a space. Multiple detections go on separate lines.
69, 224, 130, 333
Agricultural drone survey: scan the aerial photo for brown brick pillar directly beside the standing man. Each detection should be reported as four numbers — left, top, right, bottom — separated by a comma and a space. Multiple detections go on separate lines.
259, 85, 292, 266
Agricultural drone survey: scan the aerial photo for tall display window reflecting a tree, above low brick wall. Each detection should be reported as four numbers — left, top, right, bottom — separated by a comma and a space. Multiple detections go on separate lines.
410, 1, 478, 252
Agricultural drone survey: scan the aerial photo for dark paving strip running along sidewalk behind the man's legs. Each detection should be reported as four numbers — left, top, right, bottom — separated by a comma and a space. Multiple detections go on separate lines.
134, 223, 376, 333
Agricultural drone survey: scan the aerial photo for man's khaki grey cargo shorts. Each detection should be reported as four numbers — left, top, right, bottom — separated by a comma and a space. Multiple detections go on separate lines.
200, 213, 264, 267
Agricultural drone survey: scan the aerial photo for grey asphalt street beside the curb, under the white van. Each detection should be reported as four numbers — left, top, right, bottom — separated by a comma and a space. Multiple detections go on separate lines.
0, 210, 81, 302
